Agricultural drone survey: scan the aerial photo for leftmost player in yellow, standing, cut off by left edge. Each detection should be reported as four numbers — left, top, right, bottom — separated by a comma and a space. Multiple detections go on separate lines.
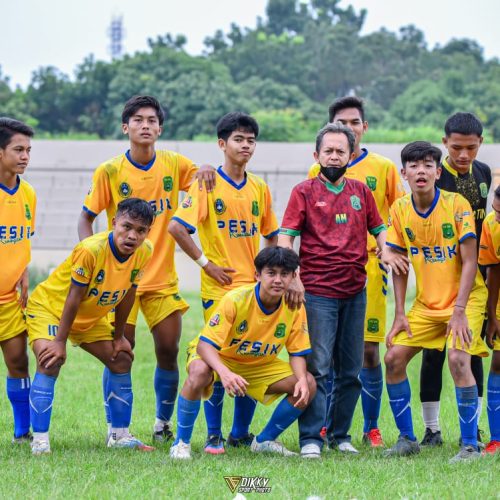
0, 117, 36, 443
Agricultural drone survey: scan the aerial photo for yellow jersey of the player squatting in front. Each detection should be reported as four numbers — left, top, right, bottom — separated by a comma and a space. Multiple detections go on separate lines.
200, 283, 311, 366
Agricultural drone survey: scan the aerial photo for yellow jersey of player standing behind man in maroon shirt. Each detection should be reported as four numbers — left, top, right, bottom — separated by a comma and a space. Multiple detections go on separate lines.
307, 149, 405, 252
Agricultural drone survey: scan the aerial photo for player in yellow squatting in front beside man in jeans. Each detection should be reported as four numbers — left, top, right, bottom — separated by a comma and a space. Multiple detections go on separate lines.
170, 247, 316, 459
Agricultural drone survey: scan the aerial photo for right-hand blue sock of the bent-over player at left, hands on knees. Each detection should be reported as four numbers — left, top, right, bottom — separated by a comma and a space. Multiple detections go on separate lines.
108, 371, 134, 429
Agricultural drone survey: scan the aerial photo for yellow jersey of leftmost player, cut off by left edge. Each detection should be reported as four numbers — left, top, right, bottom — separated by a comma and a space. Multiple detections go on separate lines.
0, 176, 36, 304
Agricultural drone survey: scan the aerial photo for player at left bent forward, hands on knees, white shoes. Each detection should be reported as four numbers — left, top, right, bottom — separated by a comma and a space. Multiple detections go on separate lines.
26, 198, 154, 455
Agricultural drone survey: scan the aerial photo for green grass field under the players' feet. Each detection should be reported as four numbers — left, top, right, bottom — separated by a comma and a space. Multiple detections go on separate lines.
0, 294, 500, 499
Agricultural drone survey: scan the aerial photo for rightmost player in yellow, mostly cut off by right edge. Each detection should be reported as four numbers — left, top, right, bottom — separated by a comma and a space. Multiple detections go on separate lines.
479, 186, 500, 454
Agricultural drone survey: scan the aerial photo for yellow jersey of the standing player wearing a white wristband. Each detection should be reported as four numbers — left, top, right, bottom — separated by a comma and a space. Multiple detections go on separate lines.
173, 167, 279, 300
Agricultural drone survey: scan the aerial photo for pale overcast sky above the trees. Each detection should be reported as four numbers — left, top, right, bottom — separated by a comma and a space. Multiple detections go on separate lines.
0, 0, 500, 87
